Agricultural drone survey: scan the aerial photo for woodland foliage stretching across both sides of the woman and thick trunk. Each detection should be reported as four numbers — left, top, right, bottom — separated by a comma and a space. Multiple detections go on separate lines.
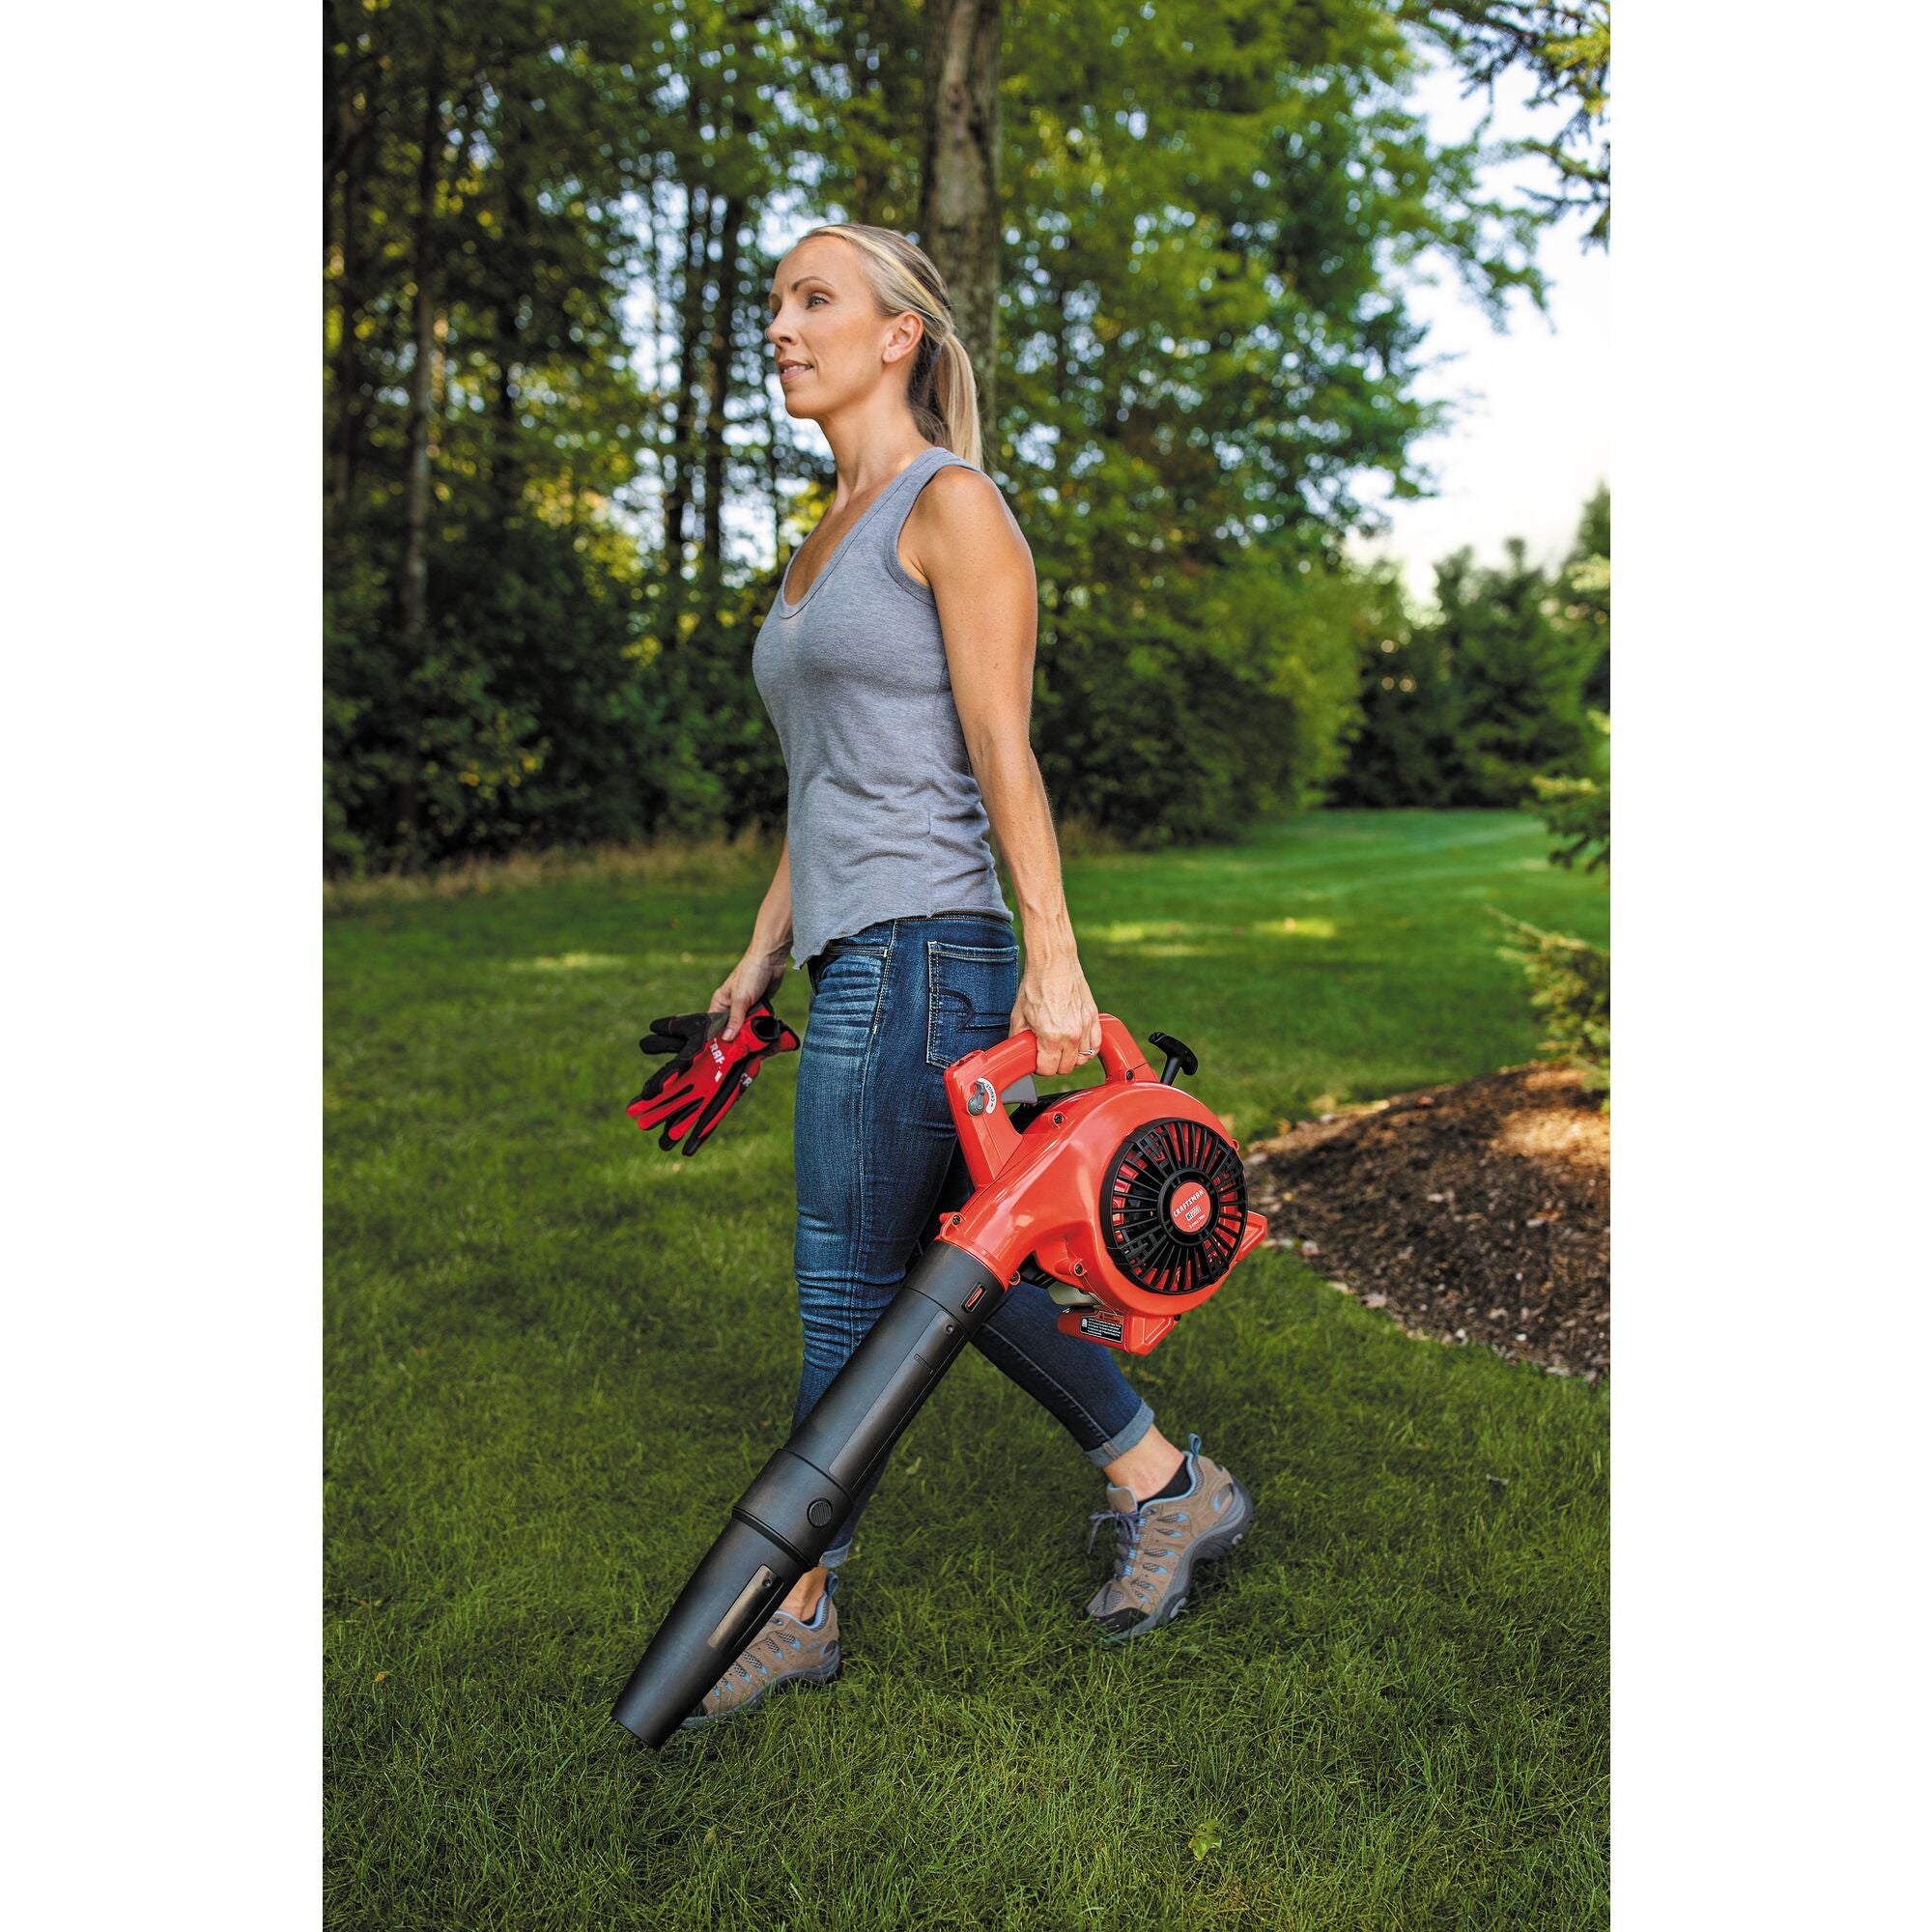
323, 0, 1582, 869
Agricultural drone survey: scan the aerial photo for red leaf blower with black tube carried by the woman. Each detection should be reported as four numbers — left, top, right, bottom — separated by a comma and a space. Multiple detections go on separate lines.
612, 1012, 1267, 1747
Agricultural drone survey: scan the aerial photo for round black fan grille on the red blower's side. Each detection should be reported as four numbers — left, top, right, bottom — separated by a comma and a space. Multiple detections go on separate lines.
1099, 1117, 1248, 1294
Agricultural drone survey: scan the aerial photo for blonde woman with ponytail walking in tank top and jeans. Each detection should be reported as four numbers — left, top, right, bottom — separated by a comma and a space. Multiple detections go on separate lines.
688, 224, 1254, 1723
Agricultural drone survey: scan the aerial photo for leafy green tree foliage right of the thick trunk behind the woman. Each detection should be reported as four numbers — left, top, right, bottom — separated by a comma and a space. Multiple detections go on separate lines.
1003, 4, 1540, 838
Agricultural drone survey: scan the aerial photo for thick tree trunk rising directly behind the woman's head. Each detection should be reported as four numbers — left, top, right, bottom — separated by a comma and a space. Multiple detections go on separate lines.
920, 0, 1003, 466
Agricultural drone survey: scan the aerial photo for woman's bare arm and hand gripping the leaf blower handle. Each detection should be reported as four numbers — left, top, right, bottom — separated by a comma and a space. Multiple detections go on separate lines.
906, 466, 1099, 1074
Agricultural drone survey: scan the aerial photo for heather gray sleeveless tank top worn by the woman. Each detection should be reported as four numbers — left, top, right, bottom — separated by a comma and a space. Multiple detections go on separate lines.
752, 444, 1012, 966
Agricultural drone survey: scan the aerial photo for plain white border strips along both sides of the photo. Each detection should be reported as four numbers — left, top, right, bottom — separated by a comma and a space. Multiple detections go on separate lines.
0, 0, 1932, 1932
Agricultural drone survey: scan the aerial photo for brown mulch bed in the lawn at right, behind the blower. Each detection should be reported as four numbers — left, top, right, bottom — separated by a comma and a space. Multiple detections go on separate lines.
1248, 1066, 1609, 1381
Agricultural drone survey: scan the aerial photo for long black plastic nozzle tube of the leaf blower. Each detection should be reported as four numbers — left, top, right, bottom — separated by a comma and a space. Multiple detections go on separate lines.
612, 1240, 1005, 1748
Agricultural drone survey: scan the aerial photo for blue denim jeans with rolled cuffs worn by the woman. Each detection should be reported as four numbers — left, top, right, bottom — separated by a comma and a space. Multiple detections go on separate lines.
792, 912, 1153, 1565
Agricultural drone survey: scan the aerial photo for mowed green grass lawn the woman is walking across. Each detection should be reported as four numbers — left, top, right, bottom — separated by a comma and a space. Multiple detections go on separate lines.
325, 813, 1609, 1932
